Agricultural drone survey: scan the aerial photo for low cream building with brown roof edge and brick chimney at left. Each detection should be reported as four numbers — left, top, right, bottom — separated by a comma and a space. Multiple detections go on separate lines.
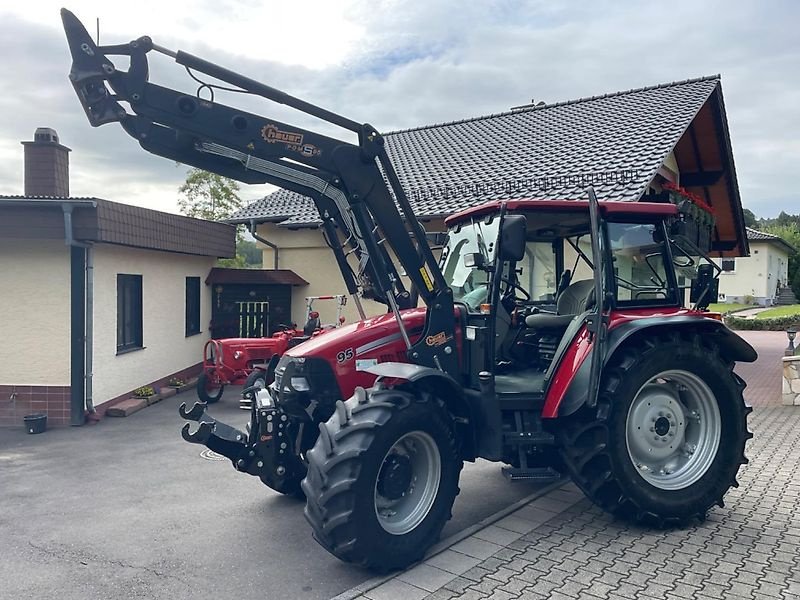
0, 129, 235, 425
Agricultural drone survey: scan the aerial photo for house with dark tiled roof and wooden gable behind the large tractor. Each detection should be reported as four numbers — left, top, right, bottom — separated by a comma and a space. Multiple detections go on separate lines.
229, 76, 748, 319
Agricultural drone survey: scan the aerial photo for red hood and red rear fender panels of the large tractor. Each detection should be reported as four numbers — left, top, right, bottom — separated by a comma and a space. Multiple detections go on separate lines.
286, 307, 707, 418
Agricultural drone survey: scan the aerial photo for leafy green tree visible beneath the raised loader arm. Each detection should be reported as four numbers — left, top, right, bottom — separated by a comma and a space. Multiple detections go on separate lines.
178, 169, 242, 221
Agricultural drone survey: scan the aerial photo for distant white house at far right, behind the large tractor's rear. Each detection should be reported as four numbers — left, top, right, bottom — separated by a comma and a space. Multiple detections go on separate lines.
716, 227, 792, 306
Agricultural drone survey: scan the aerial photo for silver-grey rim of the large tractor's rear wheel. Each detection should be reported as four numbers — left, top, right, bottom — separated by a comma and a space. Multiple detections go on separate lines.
625, 370, 722, 490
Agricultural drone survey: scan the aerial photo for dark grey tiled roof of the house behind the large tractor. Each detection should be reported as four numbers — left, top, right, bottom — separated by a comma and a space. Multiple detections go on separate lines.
231, 76, 719, 227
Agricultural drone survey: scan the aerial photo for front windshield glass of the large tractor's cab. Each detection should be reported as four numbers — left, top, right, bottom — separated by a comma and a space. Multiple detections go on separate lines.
441, 218, 500, 310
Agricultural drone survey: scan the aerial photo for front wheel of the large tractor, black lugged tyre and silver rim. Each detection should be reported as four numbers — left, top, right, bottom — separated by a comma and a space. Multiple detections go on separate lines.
303, 388, 462, 570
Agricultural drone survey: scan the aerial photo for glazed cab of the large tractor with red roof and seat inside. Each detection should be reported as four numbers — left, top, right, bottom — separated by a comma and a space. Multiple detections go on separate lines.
441, 200, 683, 404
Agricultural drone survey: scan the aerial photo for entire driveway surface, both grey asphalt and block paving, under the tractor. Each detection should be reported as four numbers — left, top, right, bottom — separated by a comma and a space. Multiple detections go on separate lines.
0, 332, 788, 600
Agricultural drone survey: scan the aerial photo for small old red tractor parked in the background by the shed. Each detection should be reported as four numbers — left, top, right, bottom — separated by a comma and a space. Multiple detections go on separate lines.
197, 294, 347, 409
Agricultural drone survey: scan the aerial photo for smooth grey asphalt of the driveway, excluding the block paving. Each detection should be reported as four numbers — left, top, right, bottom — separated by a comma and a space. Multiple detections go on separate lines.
0, 389, 552, 600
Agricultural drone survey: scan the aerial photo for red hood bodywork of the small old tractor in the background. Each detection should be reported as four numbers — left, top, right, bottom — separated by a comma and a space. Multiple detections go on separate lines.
203, 329, 303, 387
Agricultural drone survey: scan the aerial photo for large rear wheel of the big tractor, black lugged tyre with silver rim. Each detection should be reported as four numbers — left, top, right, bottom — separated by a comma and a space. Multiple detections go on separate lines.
560, 334, 753, 526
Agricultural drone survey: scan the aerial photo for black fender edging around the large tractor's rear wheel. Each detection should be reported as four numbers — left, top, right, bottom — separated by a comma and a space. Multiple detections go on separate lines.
542, 315, 758, 418
